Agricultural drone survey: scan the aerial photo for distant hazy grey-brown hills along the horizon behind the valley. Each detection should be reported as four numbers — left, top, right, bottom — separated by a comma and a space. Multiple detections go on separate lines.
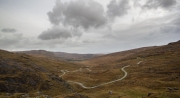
18, 50, 103, 61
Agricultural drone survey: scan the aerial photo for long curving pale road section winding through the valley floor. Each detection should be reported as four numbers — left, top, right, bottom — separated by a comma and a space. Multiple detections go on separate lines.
68, 65, 130, 89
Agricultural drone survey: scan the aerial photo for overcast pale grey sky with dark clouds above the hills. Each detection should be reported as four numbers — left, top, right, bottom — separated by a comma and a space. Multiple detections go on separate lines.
0, 0, 180, 53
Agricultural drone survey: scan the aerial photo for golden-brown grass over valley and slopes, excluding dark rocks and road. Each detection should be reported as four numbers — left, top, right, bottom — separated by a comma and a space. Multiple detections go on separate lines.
0, 42, 180, 98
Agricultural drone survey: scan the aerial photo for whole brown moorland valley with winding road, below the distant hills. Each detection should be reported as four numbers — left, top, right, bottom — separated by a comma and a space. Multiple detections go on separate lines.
0, 41, 180, 98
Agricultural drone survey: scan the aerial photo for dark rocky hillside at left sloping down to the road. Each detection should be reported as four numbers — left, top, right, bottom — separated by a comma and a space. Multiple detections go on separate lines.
0, 50, 73, 95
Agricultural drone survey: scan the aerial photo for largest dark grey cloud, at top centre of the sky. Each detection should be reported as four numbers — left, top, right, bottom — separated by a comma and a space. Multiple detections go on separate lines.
48, 0, 107, 29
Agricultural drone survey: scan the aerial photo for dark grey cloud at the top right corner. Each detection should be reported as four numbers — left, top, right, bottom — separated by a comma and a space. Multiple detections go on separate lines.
143, 0, 177, 9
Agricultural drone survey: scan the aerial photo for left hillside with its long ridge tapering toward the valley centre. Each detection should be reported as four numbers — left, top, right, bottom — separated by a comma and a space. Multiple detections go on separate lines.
0, 50, 81, 98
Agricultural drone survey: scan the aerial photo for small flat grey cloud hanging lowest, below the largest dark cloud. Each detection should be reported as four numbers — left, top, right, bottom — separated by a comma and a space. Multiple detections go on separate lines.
38, 27, 82, 40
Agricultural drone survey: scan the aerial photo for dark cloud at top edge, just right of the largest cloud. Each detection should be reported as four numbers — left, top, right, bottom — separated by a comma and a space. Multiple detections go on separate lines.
107, 0, 130, 18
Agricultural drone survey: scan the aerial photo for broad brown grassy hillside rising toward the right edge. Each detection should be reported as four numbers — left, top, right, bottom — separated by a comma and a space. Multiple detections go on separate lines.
67, 41, 180, 98
